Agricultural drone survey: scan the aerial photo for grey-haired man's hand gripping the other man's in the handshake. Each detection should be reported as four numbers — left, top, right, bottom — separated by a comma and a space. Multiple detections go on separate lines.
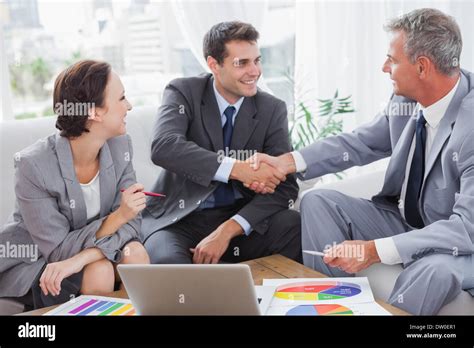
244, 153, 296, 194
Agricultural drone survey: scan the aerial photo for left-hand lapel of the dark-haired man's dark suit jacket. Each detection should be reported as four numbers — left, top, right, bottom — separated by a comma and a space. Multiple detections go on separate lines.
201, 77, 224, 152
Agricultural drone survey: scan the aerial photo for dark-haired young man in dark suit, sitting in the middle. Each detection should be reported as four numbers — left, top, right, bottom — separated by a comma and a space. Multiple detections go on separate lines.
142, 22, 302, 263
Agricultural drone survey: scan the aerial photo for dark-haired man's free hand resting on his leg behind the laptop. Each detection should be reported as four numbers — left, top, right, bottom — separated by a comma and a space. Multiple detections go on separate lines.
190, 219, 244, 263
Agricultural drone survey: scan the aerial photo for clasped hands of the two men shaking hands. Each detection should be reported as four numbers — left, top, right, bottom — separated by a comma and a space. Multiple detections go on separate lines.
230, 153, 296, 194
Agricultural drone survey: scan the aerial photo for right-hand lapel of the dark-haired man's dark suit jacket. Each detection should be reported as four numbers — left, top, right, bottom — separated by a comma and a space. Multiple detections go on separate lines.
230, 98, 258, 150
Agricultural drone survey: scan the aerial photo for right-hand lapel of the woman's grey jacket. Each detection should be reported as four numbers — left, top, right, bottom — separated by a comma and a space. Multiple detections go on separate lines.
99, 142, 116, 217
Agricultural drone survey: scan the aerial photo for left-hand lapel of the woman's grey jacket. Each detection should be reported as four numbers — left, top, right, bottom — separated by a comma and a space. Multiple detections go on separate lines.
56, 134, 87, 230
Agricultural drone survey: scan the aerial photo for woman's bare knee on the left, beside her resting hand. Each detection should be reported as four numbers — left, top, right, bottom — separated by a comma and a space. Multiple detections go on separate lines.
81, 259, 114, 295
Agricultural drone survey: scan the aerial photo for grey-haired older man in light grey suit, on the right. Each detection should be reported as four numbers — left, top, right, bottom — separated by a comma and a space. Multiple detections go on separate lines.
251, 9, 474, 314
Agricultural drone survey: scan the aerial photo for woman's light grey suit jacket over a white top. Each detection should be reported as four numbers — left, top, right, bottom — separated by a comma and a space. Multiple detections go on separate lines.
0, 134, 141, 297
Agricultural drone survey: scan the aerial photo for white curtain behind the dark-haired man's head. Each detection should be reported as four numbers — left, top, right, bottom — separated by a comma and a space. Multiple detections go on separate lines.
171, 0, 268, 91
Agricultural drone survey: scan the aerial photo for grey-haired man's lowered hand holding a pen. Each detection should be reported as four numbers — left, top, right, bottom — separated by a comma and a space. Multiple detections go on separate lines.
323, 240, 380, 273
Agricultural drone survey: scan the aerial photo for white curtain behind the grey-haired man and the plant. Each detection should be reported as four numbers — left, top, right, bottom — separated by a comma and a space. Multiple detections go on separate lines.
295, 0, 474, 179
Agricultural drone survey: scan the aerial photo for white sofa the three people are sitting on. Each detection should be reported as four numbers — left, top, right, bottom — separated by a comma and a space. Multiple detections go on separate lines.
0, 107, 474, 314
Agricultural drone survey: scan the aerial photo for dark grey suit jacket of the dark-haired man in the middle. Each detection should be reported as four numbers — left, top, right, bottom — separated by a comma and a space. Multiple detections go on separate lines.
142, 74, 298, 241
